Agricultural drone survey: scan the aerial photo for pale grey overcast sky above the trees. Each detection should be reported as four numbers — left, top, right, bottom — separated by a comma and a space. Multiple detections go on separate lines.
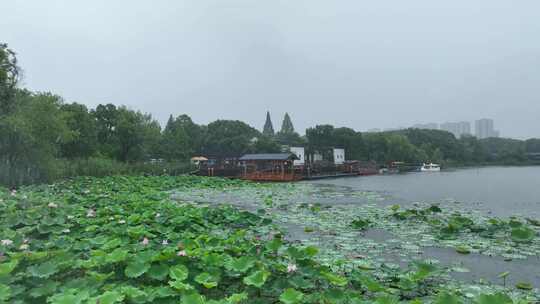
0, 0, 540, 138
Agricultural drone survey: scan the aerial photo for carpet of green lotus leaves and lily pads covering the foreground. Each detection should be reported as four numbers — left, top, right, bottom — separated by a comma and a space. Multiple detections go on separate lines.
0, 176, 540, 304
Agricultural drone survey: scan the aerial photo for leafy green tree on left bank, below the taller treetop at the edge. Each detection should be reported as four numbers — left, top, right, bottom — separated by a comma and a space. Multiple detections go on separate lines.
0, 91, 72, 185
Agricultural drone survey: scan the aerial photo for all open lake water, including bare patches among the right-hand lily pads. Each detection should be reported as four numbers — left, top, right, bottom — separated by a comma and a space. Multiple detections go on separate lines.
309, 167, 540, 287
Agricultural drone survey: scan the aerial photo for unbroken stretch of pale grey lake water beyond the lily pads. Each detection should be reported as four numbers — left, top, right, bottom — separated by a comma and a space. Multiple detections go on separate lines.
309, 167, 540, 217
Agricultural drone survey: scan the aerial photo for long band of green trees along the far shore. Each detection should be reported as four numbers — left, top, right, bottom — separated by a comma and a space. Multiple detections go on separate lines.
0, 44, 540, 185
